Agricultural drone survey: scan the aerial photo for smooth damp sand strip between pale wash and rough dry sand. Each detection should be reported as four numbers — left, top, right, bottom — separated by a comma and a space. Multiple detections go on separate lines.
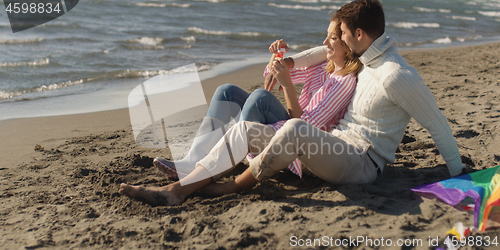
0, 63, 265, 168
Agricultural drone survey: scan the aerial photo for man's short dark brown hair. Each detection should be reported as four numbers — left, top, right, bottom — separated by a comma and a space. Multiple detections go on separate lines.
335, 0, 385, 39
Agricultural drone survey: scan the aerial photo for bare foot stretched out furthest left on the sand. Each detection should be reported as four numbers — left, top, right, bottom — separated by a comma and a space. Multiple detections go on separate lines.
118, 183, 184, 206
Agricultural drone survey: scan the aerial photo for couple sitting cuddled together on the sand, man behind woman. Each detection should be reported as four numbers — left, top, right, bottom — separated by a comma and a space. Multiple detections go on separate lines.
119, 0, 464, 205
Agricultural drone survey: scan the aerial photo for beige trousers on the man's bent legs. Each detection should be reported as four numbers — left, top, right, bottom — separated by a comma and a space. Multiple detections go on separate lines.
197, 119, 377, 184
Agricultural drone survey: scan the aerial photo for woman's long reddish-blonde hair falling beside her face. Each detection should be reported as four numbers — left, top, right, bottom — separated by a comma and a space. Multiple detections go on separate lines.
325, 16, 363, 76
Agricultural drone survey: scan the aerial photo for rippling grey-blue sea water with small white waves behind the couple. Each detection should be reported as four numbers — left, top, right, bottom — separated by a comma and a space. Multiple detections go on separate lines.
0, 0, 500, 120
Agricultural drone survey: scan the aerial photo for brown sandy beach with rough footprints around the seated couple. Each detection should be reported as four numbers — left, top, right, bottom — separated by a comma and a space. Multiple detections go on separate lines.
0, 43, 500, 249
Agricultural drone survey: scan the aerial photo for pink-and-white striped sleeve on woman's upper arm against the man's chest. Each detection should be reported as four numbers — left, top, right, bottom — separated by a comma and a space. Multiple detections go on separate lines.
300, 74, 356, 130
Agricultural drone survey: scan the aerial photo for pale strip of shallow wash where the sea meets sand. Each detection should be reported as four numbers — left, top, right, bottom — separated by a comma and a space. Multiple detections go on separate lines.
0, 39, 500, 122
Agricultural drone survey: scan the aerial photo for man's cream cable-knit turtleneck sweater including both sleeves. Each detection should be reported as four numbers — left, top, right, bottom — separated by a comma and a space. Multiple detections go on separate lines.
292, 34, 464, 176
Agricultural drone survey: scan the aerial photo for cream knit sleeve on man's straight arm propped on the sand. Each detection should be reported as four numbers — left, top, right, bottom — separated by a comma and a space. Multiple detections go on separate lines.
384, 69, 464, 176
